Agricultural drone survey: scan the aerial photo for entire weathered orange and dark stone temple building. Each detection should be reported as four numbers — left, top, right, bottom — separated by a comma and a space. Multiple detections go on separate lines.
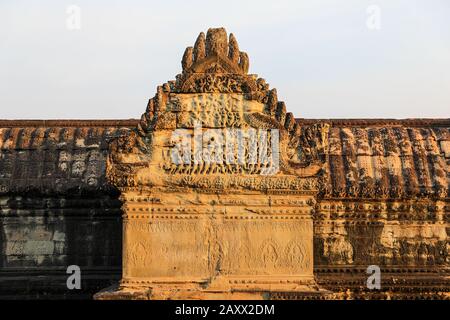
0, 29, 450, 299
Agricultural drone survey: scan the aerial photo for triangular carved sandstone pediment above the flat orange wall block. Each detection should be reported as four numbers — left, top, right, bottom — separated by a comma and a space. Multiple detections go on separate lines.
110, 28, 328, 189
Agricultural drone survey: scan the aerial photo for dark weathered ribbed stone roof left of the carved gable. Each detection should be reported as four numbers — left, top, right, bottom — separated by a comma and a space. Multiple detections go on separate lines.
0, 120, 136, 195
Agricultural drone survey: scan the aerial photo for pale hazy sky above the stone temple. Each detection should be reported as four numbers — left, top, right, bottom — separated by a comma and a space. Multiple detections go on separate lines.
0, 0, 450, 119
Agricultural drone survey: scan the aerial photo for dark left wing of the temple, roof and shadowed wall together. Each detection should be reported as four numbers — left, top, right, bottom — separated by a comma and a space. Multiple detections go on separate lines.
0, 121, 135, 298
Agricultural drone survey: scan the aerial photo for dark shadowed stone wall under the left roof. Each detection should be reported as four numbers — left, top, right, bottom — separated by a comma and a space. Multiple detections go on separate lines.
0, 195, 122, 298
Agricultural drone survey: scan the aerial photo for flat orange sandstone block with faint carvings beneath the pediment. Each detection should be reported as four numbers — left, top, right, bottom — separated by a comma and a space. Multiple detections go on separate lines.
114, 191, 317, 299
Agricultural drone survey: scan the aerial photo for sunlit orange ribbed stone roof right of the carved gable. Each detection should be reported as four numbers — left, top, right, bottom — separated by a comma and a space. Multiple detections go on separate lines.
316, 119, 450, 198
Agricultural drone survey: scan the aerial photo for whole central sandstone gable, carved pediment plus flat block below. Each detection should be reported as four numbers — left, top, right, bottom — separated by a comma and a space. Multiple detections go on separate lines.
107, 28, 328, 299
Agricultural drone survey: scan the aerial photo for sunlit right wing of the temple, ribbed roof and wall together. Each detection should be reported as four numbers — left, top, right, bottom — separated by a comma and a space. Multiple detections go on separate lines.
314, 121, 450, 297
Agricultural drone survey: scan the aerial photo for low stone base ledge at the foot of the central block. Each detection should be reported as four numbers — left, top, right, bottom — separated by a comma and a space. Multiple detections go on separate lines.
94, 276, 330, 300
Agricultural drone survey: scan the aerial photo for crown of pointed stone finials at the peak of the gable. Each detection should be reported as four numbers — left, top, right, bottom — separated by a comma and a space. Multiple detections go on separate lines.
181, 28, 249, 74
